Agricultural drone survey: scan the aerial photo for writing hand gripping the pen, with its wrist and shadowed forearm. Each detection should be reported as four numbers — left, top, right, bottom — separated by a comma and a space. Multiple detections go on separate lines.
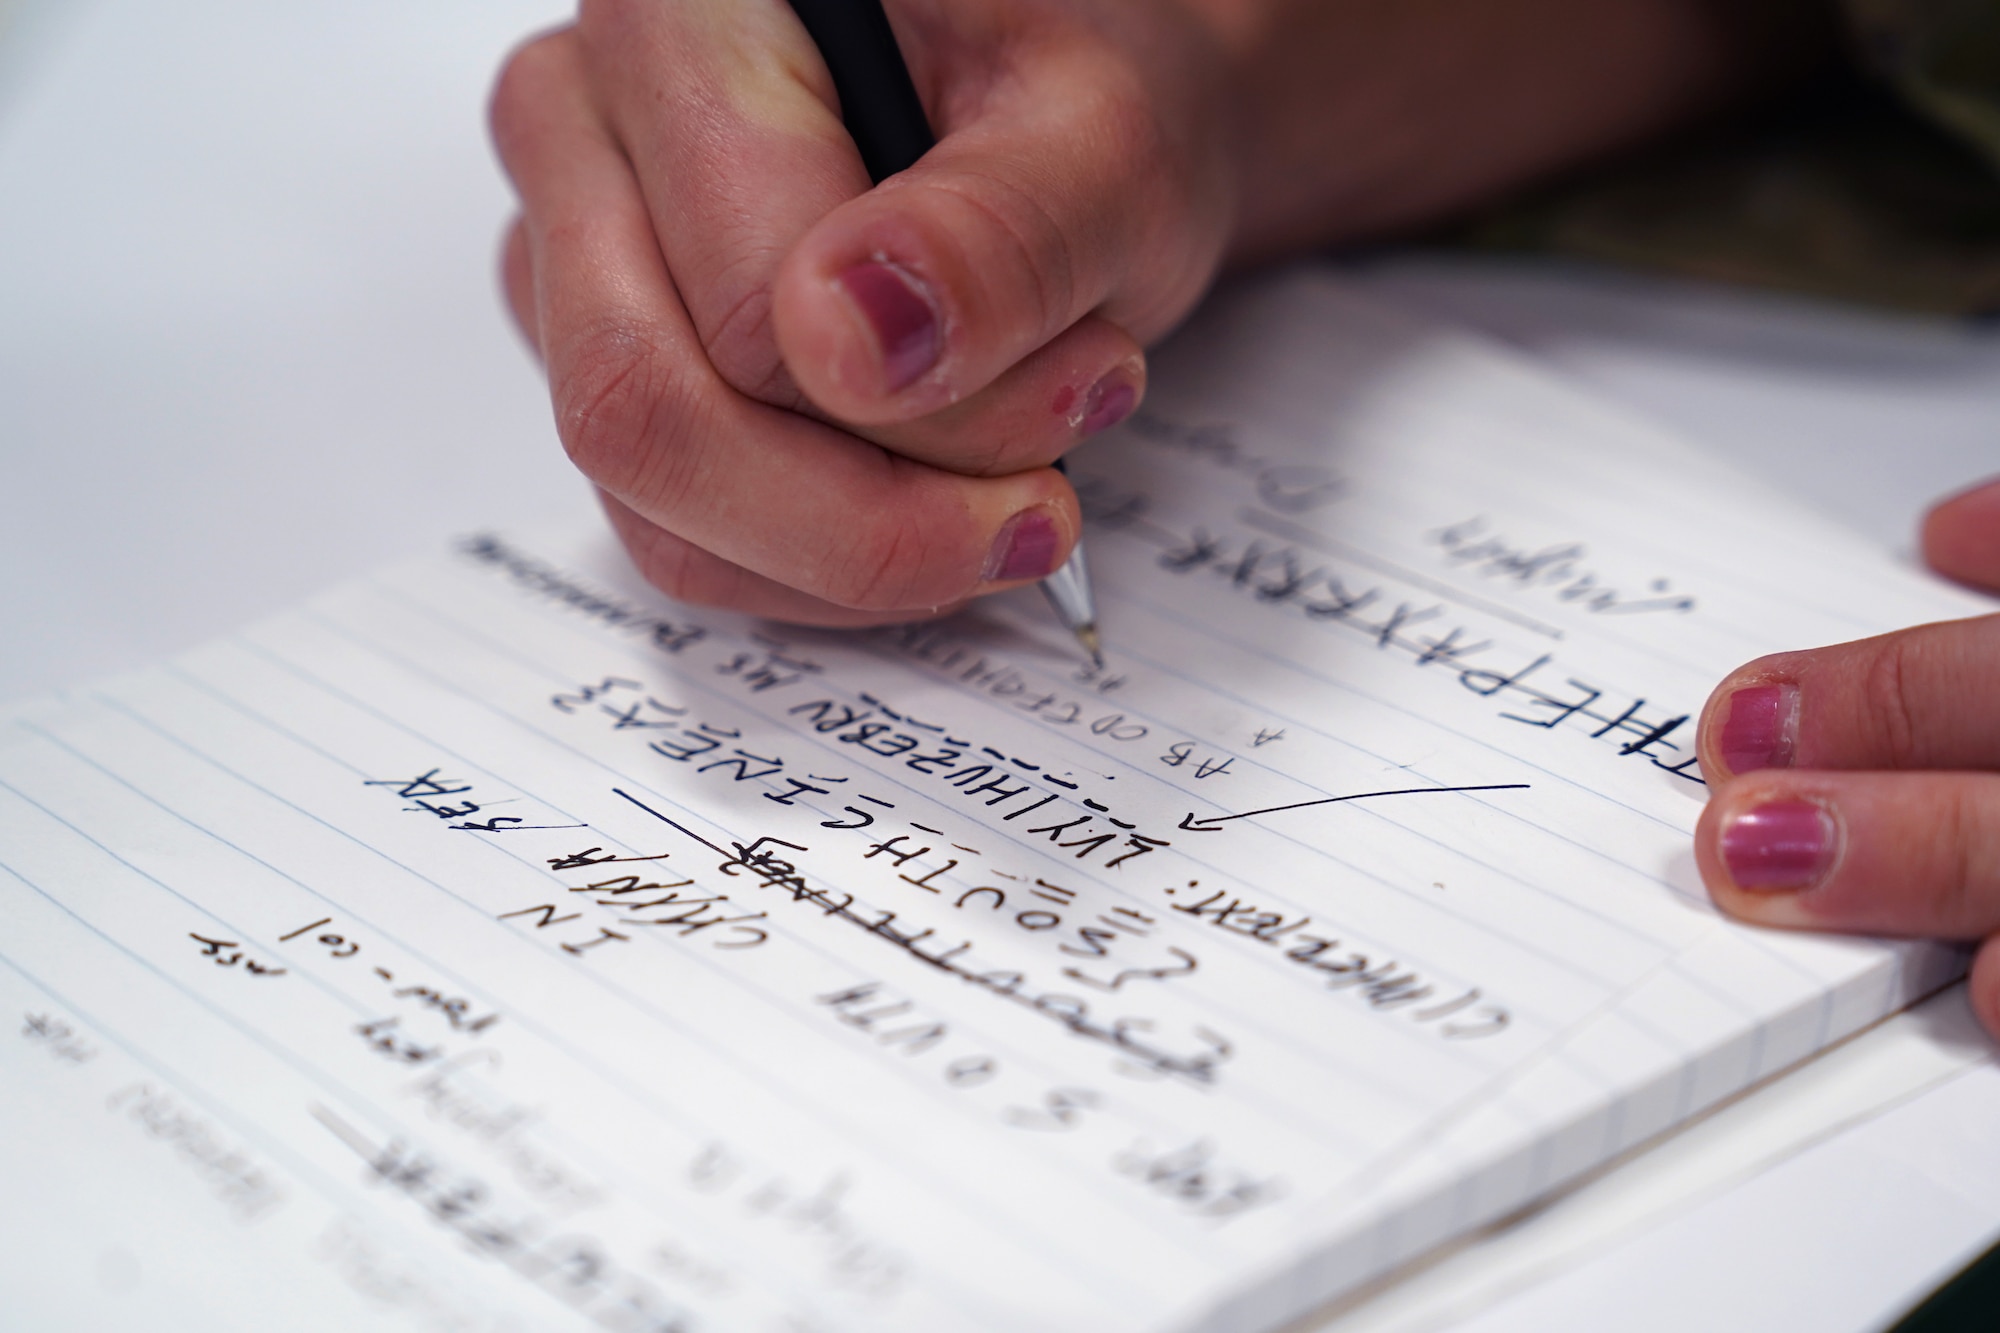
492, 0, 1824, 624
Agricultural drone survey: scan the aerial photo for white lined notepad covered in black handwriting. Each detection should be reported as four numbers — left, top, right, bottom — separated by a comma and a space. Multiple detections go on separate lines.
0, 274, 1978, 1333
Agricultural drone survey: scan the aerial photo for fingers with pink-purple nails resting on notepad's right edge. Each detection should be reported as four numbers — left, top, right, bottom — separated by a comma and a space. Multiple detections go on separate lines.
1694, 478, 2000, 1035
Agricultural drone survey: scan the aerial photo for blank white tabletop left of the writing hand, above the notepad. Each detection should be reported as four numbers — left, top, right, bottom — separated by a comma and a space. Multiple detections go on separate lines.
0, 0, 588, 699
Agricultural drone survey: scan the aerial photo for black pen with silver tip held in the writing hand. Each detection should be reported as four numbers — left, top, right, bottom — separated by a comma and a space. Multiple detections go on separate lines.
792, 0, 1104, 667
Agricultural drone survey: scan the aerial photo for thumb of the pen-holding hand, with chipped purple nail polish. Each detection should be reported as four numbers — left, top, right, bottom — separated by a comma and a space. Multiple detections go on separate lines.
772, 34, 1228, 424
